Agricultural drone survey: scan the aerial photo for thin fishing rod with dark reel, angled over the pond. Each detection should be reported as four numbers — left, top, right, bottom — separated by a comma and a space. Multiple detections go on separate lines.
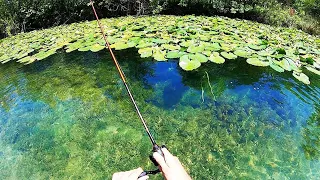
90, 0, 164, 178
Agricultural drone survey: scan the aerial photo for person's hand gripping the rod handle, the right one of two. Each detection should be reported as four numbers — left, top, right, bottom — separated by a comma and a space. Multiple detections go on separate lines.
153, 148, 191, 180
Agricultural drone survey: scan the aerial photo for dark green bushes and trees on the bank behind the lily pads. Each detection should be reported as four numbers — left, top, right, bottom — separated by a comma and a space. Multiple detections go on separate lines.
0, 0, 320, 38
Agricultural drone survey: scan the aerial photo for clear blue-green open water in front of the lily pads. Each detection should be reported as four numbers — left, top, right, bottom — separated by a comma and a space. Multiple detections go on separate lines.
0, 49, 320, 180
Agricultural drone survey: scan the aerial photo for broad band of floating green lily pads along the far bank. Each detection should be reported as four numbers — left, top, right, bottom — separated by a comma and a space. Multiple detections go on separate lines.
0, 16, 320, 84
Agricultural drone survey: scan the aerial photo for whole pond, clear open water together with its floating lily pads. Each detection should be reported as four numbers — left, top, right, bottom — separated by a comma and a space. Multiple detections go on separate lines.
0, 15, 320, 180
